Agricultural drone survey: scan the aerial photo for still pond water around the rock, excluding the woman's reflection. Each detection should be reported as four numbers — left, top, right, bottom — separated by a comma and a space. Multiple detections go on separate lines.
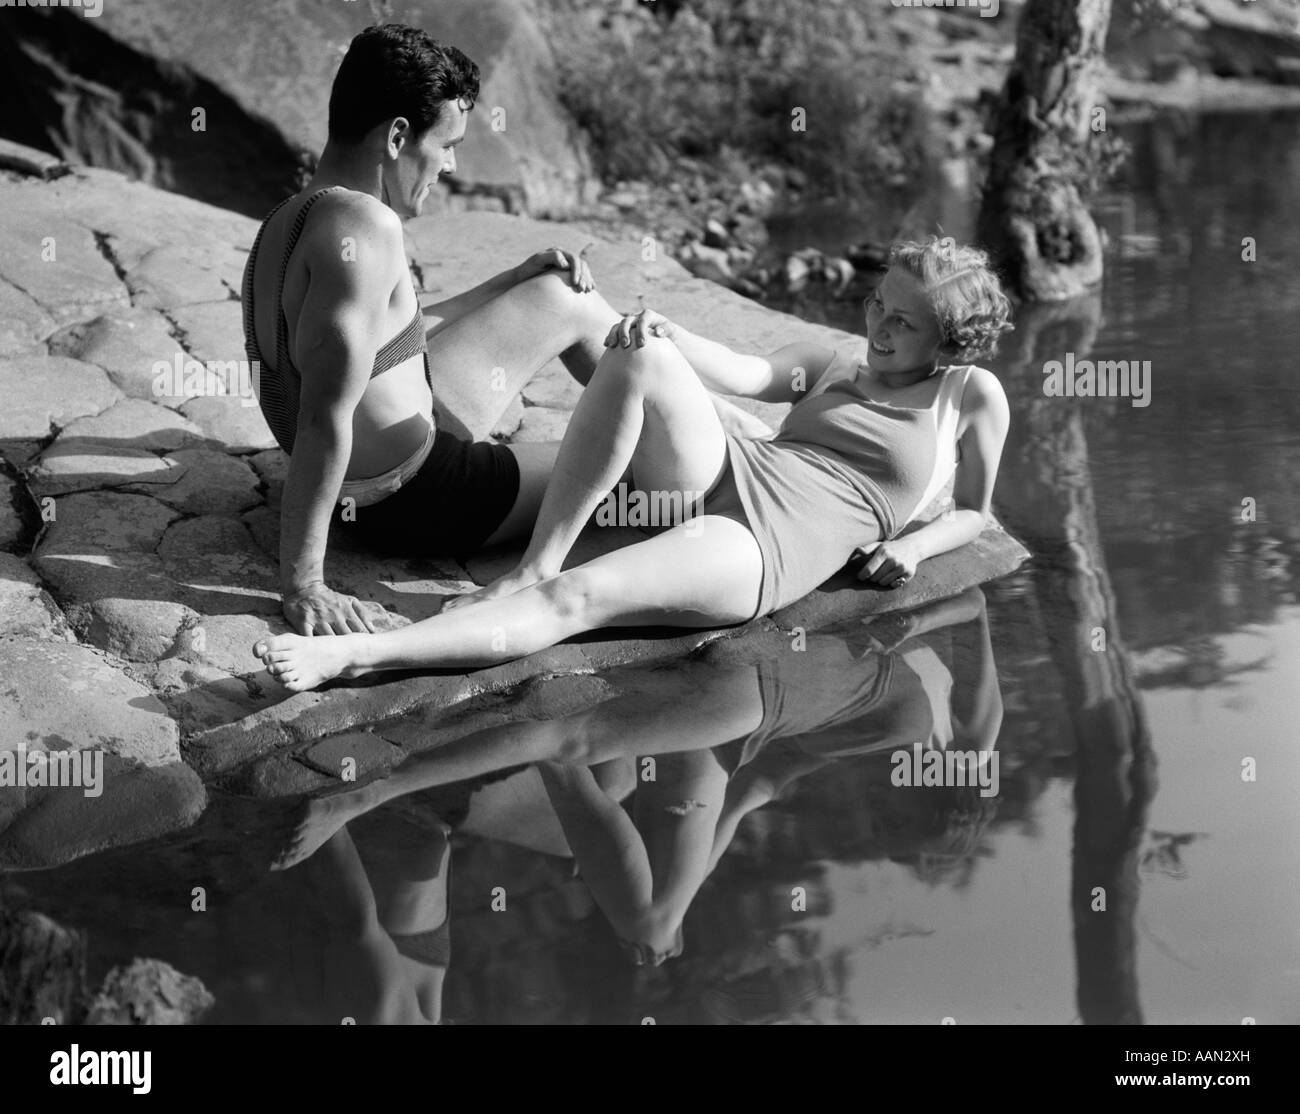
0, 116, 1300, 1024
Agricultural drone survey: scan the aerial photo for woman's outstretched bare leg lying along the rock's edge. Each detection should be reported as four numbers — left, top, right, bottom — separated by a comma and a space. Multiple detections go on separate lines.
254, 515, 763, 692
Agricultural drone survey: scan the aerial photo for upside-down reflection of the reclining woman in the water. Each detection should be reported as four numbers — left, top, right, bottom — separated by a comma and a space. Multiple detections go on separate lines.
274, 589, 1001, 963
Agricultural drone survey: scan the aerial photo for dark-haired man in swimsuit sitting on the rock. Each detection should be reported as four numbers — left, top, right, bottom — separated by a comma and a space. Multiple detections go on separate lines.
243, 25, 619, 634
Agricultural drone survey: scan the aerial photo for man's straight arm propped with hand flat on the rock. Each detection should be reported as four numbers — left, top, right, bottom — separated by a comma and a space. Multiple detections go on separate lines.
280, 204, 404, 634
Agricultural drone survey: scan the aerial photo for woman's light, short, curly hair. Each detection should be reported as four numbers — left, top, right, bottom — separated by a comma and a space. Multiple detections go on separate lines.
889, 237, 1014, 363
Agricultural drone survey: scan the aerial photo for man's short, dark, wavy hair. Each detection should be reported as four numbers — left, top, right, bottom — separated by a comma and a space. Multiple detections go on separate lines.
329, 23, 478, 143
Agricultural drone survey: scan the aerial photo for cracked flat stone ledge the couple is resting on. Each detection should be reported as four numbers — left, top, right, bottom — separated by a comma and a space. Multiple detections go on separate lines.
0, 144, 1027, 867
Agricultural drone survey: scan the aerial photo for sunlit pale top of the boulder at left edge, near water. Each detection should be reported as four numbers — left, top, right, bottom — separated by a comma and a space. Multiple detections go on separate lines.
0, 636, 181, 766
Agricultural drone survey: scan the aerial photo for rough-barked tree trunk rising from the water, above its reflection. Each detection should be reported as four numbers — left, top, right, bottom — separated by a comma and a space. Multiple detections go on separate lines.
979, 0, 1110, 302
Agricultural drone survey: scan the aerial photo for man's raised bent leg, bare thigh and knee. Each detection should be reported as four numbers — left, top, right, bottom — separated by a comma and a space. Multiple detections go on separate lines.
418, 273, 619, 441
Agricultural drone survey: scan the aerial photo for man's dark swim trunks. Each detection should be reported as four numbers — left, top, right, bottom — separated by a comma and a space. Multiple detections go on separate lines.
335, 429, 519, 558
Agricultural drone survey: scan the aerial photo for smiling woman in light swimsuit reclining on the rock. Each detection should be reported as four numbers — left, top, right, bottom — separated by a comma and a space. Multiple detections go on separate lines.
254, 238, 1010, 692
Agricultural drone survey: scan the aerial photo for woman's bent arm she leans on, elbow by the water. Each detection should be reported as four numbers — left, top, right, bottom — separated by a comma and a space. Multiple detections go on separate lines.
858, 368, 1011, 586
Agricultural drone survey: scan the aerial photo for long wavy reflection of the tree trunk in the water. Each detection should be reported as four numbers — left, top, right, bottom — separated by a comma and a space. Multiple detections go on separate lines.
998, 296, 1157, 1024
